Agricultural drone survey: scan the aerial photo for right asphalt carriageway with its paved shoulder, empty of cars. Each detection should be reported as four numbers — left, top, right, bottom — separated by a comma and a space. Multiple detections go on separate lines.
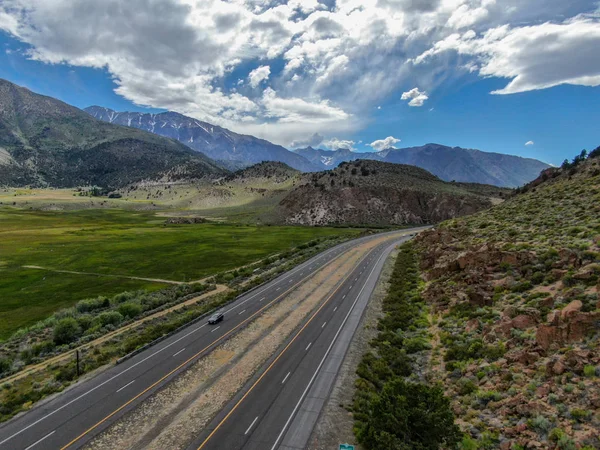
188, 237, 408, 450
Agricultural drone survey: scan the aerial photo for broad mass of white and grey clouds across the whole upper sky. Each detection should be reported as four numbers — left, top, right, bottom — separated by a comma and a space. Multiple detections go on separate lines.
0, 0, 600, 145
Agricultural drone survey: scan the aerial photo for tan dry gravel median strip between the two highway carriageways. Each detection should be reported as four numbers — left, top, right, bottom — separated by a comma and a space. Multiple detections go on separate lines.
87, 234, 394, 449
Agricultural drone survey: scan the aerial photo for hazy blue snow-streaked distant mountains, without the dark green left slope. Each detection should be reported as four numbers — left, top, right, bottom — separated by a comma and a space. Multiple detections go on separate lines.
85, 106, 550, 187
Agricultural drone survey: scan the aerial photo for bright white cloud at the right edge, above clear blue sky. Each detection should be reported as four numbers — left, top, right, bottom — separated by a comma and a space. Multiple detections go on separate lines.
414, 16, 600, 94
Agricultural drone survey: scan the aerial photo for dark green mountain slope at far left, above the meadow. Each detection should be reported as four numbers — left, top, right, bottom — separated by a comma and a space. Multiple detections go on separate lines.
0, 79, 227, 188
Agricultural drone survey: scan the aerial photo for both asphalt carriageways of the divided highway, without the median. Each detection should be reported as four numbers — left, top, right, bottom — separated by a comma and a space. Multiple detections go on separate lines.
0, 230, 422, 450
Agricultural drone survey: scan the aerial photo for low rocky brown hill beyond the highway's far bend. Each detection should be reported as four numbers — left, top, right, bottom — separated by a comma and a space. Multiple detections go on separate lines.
280, 161, 509, 225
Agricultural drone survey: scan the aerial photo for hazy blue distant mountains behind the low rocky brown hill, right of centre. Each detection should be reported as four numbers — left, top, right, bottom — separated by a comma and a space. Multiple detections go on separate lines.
295, 144, 550, 187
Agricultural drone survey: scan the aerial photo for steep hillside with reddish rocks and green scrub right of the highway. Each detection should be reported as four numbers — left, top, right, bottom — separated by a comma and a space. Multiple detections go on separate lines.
416, 149, 600, 449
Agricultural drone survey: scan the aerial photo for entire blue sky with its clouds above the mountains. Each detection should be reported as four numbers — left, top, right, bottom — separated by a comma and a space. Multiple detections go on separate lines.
0, 0, 600, 164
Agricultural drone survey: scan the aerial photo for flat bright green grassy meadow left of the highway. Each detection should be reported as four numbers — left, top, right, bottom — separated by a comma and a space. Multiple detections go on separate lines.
0, 207, 358, 339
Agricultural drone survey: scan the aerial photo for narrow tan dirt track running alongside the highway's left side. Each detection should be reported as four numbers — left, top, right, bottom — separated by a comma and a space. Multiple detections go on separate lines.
2, 284, 229, 383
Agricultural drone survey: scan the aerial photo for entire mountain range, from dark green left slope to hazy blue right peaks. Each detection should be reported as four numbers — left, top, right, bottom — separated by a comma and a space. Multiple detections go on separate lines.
0, 80, 549, 188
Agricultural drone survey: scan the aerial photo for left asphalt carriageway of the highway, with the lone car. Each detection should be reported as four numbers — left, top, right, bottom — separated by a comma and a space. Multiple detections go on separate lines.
0, 232, 422, 450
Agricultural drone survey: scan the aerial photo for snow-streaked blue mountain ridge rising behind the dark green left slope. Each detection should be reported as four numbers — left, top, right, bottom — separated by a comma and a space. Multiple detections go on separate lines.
85, 106, 319, 172
